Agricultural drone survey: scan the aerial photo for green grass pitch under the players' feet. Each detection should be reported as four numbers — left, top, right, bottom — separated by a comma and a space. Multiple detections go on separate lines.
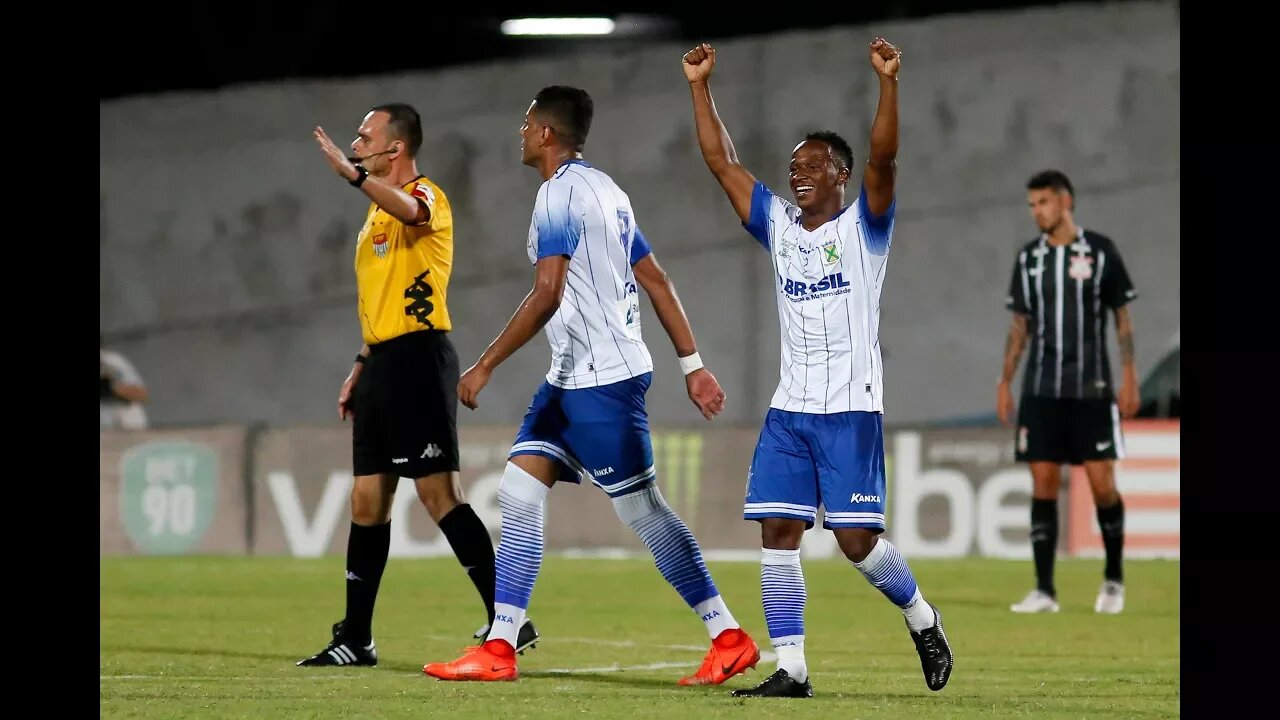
100, 557, 1179, 720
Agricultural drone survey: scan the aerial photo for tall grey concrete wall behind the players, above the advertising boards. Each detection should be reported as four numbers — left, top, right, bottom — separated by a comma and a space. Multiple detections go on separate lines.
100, 3, 1181, 425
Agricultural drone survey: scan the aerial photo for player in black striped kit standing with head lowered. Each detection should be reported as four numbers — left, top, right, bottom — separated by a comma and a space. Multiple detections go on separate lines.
996, 170, 1138, 614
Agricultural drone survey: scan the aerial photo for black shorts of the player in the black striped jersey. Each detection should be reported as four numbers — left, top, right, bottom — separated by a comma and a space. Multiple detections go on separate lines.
1015, 396, 1124, 465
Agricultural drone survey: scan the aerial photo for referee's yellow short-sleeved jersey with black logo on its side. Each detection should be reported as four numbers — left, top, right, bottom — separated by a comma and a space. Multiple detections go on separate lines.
356, 176, 453, 345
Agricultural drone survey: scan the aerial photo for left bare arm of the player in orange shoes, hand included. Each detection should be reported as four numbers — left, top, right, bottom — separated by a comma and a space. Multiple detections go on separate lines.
458, 255, 570, 410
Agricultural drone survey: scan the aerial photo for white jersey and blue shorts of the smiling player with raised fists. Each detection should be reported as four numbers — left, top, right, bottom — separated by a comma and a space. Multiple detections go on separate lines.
744, 182, 897, 530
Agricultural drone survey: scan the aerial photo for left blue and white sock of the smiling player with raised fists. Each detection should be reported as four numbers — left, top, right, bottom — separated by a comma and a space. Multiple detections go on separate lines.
760, 547, 809, 683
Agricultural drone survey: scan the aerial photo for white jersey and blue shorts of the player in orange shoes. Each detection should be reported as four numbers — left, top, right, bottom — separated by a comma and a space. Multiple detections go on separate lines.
511, 160, 654, 497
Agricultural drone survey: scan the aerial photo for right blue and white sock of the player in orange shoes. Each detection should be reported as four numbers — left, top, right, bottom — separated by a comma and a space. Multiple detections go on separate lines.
613, 483, 739, 639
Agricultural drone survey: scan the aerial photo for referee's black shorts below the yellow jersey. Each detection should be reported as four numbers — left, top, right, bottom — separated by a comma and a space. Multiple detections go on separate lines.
351, 331, 458, 478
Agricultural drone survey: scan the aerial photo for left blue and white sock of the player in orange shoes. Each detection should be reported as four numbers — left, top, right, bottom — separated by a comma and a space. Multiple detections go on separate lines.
486, 461, 550, 647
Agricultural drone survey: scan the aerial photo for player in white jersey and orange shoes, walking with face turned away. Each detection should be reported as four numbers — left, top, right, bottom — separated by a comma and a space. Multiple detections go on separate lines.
422, 86, 760, 685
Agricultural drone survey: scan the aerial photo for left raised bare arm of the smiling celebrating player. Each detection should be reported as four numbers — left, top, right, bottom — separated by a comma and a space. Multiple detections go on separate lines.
681, 42, 752, 223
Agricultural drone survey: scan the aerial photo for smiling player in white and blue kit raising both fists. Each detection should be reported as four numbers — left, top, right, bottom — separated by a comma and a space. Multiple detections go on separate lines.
682, 37, 952, 697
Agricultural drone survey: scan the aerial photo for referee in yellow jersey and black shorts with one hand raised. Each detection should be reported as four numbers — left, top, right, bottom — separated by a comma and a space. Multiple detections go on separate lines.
298, 102, 538, 666
